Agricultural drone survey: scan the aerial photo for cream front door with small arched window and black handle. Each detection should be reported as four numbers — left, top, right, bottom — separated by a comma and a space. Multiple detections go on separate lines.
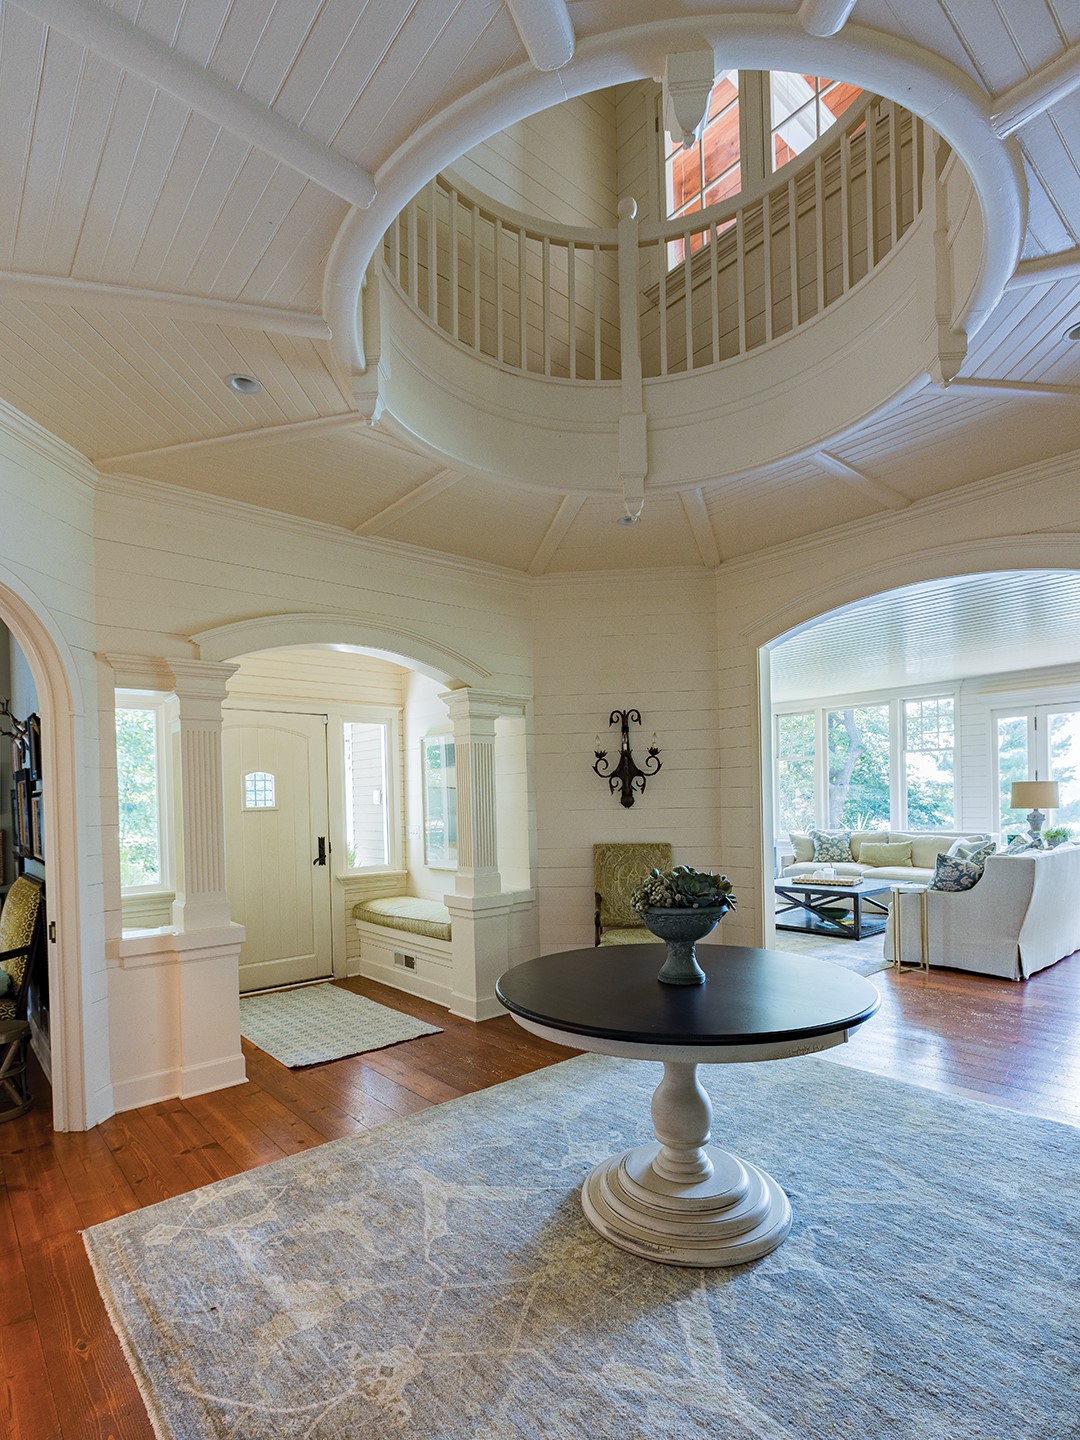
222, 710, 334, 991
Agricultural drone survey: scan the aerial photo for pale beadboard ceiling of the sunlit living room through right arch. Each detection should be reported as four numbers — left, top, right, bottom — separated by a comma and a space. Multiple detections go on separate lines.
770, 570, 1080, 704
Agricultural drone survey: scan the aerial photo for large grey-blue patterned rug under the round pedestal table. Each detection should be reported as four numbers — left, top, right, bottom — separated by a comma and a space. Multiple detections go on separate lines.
85, 1056, 1080, 1440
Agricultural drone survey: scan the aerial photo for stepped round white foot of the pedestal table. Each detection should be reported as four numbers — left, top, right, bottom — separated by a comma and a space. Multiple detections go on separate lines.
582, 1145, 791, 1266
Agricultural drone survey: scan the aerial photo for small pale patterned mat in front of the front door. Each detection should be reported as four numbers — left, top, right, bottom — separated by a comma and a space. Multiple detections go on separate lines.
240, 985, 441, 1068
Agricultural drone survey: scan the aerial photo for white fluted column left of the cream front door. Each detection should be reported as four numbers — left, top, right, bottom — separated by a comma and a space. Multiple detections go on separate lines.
170, 660, 236, 930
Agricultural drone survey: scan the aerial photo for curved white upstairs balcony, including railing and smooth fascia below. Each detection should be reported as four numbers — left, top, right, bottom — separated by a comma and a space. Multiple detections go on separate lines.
380, 96, 982, 505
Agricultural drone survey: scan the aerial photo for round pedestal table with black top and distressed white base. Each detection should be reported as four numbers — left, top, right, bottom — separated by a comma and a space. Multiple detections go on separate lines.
495, 945, 880, 1266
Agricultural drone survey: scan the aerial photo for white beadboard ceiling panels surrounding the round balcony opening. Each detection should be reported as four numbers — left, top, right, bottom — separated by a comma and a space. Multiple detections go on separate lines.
0, 0, 1080, 575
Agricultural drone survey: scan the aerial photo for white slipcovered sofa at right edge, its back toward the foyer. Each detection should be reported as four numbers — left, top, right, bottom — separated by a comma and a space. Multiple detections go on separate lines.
886, 845, 1080, 981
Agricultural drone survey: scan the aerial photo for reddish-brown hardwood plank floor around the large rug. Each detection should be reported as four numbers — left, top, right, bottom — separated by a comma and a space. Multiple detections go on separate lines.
0, 953, 1080, 1440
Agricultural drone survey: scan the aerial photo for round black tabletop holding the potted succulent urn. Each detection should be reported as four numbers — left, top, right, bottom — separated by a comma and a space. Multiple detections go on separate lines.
495, 945, 880, 1045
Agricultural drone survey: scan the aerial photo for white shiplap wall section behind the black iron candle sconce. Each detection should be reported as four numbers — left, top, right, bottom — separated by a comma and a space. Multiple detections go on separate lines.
534, 572, 727, 952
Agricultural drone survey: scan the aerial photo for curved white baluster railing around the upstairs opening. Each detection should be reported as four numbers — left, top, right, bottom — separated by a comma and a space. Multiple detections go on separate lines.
383, 96, 927, 383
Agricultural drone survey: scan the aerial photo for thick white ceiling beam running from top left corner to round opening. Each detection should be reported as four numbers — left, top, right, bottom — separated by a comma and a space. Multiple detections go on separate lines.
13, 0, 376, 209
